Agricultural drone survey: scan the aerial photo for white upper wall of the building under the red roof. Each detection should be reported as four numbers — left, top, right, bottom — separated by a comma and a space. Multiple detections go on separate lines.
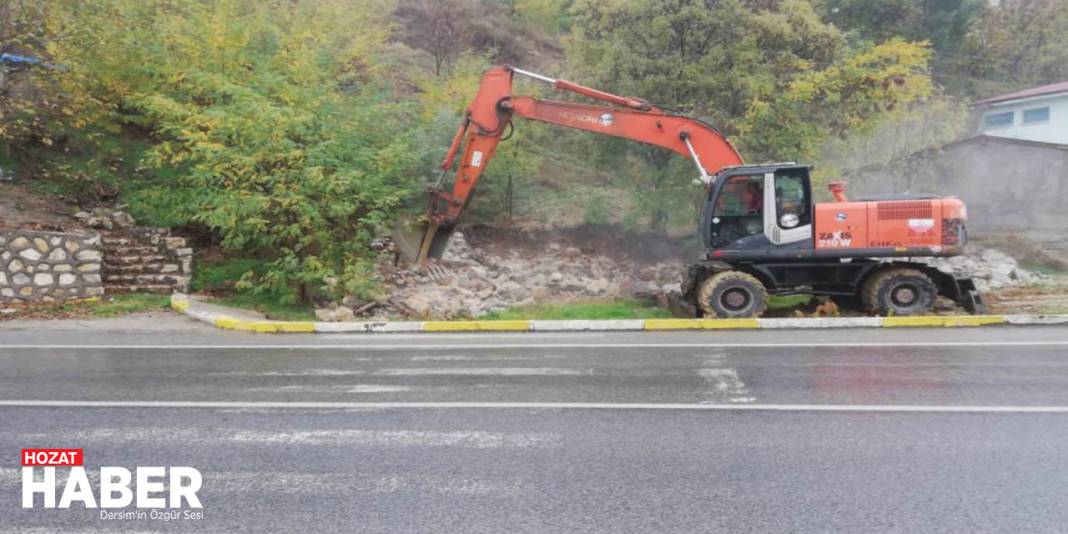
978, 93, 1068, 144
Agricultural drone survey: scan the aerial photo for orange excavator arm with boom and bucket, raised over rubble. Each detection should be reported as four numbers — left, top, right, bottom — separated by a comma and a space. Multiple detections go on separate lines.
398, 66, 742, 263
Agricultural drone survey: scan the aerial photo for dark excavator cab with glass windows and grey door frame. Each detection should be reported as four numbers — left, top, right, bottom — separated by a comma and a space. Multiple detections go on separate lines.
701, 163, 813, 251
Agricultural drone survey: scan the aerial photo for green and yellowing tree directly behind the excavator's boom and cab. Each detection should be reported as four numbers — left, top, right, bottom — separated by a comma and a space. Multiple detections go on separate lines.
567, 0, 930, 230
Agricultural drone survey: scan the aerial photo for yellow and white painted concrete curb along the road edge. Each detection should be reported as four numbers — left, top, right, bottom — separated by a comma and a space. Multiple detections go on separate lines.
171, 294, 1068, 333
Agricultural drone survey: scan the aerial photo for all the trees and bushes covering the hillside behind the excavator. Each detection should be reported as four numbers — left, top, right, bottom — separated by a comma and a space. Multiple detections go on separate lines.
0, 0, 1068, 301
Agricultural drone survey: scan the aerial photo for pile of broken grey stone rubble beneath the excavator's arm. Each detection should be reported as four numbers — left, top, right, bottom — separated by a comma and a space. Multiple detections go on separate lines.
316, 232, 685, 321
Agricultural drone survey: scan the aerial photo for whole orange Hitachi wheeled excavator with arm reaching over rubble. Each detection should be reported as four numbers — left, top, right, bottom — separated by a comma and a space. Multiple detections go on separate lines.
394, 66, 985, 318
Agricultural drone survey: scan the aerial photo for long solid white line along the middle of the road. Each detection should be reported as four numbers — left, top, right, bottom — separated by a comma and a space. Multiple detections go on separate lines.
0, 401, 1068, 413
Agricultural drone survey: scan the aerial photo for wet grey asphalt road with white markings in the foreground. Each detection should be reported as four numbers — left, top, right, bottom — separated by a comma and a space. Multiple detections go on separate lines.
0, 326, 1068, 533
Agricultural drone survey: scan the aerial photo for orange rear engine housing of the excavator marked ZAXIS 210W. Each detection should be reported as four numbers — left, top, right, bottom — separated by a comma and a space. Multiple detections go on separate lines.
813, 198, 968, 255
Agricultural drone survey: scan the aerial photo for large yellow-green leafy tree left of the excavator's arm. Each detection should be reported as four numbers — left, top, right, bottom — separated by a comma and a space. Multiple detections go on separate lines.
49, 0, 417, 299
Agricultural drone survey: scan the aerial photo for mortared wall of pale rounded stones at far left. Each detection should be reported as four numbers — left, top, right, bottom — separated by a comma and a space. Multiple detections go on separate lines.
0, 230, 104, 303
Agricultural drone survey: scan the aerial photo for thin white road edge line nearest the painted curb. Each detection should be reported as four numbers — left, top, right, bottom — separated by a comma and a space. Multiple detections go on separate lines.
0, 341, 1068, 354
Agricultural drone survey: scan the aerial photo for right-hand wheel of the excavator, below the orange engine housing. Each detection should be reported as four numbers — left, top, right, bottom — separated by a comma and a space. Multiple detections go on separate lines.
861, 267, 938, 316
